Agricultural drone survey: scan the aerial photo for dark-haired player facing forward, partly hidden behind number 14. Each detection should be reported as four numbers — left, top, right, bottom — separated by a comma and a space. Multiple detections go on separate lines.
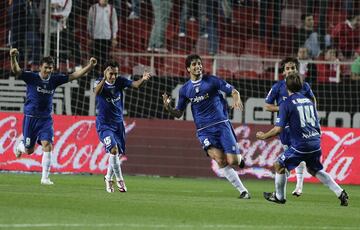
265, 57, 316, 197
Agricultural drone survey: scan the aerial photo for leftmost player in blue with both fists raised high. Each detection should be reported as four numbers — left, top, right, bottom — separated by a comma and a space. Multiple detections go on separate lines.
10, 48, 97, 185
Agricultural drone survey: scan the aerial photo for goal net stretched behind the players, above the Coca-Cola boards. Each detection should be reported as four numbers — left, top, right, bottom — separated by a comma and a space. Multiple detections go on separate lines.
0, 0, 360, 127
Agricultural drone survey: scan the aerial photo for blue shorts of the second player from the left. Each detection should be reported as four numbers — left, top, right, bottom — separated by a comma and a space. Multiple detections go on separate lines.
96, 122, 125, 154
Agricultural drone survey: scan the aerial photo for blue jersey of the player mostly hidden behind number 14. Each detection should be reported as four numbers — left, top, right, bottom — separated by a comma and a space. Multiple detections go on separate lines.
265, 80, 315, 106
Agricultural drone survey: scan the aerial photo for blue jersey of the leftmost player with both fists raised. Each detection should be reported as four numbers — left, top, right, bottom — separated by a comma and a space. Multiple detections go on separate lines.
19, 71, 69, 118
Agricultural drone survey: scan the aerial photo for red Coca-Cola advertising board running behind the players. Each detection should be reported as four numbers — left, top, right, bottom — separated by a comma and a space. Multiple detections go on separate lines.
0, 113, 360, 184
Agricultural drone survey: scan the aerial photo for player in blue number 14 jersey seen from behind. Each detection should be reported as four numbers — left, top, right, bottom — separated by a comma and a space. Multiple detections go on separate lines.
256, 73, 348, 206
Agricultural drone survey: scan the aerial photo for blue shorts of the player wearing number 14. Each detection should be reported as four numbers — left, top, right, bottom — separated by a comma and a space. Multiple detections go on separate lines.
278, 147, 323, 173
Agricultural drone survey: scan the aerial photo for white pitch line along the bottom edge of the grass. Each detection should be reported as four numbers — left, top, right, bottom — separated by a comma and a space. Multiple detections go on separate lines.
0, 223, 359, 230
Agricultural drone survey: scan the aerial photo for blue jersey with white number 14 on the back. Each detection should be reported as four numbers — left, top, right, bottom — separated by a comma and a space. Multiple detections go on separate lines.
276, 93, 320, 153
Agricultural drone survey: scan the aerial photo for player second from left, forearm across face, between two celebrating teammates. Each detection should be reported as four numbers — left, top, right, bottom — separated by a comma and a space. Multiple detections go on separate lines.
94, 60, 150, 193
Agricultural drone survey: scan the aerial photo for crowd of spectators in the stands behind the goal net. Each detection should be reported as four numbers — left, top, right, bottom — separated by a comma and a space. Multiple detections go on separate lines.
7, 0, 360, 82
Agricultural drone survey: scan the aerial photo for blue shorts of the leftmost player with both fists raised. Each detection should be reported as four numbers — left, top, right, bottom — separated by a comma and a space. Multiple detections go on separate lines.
23, 115, 54, 149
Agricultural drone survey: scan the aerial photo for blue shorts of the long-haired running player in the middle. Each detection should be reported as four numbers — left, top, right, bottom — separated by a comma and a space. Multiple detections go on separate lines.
197, 121, 240, 154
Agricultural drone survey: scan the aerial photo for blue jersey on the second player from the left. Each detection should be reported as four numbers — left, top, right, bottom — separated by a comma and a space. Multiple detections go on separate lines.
94, 76, 132, 123
